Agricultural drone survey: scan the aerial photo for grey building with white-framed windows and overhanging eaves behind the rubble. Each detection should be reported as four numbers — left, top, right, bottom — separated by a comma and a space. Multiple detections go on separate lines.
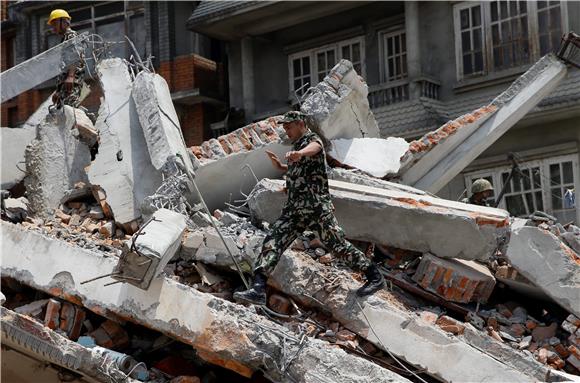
188, 1, 580, 222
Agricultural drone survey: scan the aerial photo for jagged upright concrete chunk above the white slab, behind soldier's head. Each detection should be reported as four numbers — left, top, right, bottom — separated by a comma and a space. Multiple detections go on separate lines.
300, 59, 380, 140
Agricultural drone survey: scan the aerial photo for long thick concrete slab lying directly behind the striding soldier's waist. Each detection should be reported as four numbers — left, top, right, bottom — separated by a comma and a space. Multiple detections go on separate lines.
249, 179, 509, 260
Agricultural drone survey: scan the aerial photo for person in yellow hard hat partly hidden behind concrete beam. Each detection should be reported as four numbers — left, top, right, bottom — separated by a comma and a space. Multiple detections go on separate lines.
47, 9, 85, 108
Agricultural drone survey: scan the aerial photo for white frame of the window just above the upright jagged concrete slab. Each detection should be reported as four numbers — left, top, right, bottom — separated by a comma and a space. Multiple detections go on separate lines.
288, 35, 366, 98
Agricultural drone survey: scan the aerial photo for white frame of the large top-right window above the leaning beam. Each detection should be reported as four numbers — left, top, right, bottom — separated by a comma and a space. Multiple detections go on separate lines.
452, 1, 568, 82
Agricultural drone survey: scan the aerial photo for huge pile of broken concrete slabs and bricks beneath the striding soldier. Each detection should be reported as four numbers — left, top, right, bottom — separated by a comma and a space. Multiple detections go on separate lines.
1, 43, 580, 383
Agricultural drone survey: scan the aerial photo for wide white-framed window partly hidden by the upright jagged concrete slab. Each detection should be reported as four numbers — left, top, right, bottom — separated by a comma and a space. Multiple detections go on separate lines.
288, 37, 365, 96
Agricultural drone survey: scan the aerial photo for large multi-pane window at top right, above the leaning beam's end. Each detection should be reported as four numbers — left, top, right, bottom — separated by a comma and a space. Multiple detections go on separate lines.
454, 1, 567, 79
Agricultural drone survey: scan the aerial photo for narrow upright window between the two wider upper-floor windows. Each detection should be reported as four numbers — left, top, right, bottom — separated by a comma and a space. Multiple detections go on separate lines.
379, 30, 407, 82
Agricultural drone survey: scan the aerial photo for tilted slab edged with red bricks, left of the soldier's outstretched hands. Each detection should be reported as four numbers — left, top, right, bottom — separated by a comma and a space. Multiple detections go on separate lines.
192, 116, 290, 210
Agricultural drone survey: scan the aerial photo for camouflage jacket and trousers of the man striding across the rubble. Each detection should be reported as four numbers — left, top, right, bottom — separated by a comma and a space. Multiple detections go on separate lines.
254, 130, 370, 274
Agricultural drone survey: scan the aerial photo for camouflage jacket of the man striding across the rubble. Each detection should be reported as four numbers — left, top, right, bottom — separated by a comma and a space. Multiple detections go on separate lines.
285, 130, 332, 211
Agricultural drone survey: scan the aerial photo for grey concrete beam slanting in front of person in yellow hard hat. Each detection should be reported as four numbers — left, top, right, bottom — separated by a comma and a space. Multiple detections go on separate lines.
0, 33, 92, 102
